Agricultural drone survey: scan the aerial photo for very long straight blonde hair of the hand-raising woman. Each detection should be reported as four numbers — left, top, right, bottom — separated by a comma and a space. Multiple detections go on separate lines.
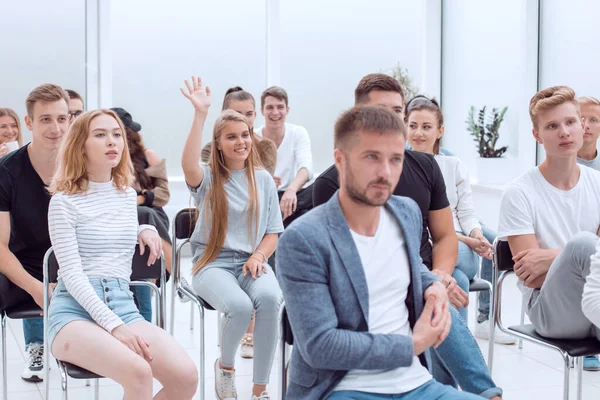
192, 110, 259, 274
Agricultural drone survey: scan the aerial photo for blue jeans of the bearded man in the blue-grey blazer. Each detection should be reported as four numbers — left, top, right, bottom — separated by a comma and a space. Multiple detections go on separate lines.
327, 379, 481, 400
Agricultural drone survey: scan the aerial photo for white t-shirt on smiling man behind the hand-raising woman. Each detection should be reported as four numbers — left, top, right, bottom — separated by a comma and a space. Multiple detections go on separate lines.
256, 124, 313, 192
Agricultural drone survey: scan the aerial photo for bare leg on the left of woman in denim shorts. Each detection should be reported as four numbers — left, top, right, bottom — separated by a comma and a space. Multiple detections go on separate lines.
52, 321, 152, 400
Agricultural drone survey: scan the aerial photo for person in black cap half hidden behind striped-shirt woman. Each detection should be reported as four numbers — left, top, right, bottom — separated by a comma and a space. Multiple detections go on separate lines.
111, 107, 172, 322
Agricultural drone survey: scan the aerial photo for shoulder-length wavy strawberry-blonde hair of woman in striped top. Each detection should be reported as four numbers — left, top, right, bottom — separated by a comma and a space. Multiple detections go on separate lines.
48, 109, 133, 194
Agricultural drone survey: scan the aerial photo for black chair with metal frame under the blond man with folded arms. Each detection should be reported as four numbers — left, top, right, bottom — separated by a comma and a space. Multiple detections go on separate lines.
488, 239, 600, 400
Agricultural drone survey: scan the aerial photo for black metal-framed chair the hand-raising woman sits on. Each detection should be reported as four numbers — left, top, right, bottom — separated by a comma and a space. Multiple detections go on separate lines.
170, 208, 214, 400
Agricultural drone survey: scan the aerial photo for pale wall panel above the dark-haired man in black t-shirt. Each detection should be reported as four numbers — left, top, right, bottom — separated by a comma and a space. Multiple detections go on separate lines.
280, 0, 425, 173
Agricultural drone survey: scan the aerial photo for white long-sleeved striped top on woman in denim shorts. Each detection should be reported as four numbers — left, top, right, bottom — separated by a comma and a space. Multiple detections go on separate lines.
48, 181, 155, 333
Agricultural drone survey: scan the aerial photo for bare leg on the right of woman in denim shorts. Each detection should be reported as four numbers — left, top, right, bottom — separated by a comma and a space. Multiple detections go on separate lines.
129, 321, 198, 400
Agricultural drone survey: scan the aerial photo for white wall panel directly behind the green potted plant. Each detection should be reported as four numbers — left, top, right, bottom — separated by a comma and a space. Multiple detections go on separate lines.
442, 0, 537, 182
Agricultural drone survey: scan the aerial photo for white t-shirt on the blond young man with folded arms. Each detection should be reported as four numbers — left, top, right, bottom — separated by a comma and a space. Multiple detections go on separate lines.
498, 166, 600, 297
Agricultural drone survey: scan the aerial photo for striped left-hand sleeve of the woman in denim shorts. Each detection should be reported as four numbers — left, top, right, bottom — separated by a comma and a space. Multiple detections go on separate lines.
48, 194, 123, 333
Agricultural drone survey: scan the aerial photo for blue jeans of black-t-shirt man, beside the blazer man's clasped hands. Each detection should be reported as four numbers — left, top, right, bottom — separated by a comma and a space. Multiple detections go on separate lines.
432, 307, 502, 399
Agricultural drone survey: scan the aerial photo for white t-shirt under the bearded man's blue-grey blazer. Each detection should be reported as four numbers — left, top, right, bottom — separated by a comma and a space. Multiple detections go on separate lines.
334, 208, 432, 394
